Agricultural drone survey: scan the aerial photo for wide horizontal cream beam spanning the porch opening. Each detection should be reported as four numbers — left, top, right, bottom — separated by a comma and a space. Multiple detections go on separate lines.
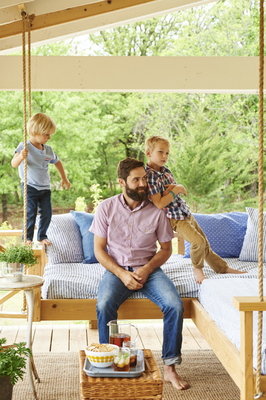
0, 56, 266, 94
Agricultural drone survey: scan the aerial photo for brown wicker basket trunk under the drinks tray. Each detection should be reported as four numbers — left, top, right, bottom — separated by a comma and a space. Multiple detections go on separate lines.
79, 350, 163, 400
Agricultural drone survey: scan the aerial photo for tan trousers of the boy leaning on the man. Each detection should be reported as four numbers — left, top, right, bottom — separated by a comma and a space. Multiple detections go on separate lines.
170, 214, 228, 274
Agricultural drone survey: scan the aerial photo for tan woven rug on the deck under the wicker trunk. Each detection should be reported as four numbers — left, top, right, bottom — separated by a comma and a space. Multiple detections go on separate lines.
12, 350, 240, 400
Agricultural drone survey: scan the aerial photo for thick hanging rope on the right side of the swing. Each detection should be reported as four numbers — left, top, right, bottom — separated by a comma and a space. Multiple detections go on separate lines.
255, 0, 264, 399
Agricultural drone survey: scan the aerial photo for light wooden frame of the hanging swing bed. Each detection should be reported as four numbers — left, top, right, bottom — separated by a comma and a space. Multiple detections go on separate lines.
0, 231, 266, 400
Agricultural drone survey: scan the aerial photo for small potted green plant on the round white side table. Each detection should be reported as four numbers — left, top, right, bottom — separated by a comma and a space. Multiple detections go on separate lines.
0, 244, 37, 282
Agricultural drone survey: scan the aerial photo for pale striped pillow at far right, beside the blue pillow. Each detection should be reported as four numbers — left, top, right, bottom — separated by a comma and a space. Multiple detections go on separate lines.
239, 207, 266, 262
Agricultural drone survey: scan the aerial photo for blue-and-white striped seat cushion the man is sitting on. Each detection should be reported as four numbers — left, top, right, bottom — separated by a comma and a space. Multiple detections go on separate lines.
42, 254, 260, 299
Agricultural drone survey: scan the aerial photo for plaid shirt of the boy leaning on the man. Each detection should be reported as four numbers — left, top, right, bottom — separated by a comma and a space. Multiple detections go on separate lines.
145, 164, 191, 220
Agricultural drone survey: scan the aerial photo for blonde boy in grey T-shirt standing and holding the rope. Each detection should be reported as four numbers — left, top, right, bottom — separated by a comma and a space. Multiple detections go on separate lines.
11, 113, 70, 246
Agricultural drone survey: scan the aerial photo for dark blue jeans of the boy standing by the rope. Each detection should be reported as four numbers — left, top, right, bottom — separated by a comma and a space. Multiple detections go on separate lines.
21, 184, 52, 241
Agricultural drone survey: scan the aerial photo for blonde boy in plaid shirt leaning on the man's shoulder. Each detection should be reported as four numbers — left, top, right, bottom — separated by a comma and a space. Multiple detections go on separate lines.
145, 136, 243, 283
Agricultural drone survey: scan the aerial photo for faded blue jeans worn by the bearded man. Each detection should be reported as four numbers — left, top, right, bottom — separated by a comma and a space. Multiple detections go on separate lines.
97, 268, 184, 365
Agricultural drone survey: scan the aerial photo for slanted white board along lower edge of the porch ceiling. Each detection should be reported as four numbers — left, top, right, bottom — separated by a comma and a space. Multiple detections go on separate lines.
0, 0, 218, 54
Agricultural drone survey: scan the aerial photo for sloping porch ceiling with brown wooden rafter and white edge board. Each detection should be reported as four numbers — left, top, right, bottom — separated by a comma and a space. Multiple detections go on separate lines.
0, 0, 217, 54
